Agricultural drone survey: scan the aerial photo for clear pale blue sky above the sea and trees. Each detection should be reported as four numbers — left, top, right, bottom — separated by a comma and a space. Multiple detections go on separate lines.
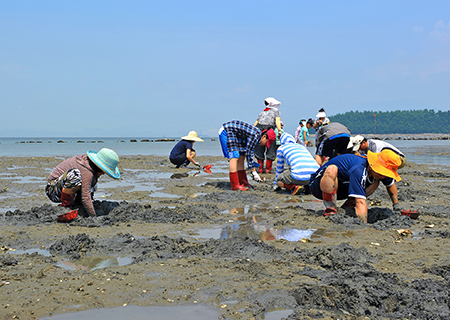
0, 0, 450, 137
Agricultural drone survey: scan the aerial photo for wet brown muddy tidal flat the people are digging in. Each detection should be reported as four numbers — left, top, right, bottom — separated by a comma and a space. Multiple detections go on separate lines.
0, 156, 450, 319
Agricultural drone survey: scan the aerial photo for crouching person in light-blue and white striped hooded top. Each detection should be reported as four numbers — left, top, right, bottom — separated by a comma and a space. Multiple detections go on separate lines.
274, 132, 319, 195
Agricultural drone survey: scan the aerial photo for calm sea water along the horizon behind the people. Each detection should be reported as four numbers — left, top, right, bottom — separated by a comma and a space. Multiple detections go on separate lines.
0, 138, 450, 166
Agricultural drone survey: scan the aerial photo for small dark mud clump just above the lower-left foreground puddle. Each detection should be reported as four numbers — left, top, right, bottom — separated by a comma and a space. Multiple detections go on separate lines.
49, 233, 95, 259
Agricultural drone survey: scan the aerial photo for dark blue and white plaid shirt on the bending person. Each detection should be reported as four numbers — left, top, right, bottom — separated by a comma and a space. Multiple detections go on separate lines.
223, 120, 261, 168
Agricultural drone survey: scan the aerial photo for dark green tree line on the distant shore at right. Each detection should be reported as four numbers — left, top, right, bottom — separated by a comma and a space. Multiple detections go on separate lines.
329, 109, 450, 134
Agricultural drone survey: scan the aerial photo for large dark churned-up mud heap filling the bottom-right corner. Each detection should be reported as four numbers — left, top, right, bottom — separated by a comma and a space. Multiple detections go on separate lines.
292, 244, 450, 319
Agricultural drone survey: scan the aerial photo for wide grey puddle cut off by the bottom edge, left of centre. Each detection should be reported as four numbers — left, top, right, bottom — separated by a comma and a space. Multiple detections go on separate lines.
41, 305, 220, 320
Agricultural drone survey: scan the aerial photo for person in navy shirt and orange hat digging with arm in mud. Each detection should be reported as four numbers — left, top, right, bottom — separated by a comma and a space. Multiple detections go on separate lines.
309, 150, 401, 222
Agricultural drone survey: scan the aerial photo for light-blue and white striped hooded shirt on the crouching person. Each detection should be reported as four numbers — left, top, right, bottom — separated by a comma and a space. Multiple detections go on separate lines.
275, 132, 319, 181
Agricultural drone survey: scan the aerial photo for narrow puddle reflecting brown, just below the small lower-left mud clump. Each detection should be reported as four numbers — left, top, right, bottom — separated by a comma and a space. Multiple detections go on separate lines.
56, 256, 133, 270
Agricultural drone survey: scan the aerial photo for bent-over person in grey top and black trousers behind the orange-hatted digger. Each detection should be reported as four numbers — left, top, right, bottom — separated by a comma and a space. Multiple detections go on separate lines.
315, 122, 351, 166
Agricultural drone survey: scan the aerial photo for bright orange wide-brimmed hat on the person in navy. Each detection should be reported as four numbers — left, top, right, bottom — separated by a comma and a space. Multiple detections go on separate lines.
367, 149, 402, 181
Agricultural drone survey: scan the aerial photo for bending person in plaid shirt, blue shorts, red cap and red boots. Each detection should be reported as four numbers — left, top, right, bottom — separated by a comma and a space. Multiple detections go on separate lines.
219, 120, 276, 191
